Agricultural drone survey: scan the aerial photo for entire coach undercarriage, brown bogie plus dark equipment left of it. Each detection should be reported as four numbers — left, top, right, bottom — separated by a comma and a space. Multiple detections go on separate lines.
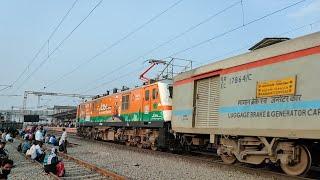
170, 134, 320, 176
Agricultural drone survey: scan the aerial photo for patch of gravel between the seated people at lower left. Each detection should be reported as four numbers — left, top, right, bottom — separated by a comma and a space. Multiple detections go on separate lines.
5, 140, 53, 180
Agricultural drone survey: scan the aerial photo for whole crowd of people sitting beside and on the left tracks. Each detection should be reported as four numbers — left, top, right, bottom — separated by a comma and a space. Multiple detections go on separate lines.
0, 126, 67, 179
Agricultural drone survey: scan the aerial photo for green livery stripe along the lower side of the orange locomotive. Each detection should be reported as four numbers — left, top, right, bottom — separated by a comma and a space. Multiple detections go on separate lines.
78, 111, 163, 123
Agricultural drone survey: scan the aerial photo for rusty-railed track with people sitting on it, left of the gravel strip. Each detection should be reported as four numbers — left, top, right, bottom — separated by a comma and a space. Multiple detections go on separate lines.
15, 139, 126, 180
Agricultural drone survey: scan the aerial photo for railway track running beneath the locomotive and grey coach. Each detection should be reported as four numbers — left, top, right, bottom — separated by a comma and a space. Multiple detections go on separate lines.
51, 129, 320, 180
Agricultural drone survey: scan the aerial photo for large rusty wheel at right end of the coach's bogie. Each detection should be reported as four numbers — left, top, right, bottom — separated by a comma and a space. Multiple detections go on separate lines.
280, 145, 312, 176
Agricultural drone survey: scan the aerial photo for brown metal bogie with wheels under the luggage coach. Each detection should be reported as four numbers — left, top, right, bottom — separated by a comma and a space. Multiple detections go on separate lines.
217, 137, 312, 175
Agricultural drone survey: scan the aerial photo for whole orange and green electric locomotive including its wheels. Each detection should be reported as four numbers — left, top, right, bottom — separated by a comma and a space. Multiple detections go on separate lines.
77, 82, 172, 149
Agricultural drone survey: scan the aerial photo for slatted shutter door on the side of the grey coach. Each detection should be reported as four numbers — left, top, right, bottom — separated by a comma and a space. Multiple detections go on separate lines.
194, 76, 220, 128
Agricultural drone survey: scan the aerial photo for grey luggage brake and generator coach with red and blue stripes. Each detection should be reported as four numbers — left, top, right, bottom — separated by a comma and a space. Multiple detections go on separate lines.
171, 32, 320, 175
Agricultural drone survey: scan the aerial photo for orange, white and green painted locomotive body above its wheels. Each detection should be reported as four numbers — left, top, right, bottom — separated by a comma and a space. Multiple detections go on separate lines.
78, 83, 172, 123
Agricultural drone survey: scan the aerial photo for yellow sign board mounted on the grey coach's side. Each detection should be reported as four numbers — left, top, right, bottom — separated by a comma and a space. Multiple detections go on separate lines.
257, 77, 296, 98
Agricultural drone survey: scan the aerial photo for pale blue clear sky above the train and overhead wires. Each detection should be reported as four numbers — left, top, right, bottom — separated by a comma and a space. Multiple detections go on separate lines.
0, 0, 320, 109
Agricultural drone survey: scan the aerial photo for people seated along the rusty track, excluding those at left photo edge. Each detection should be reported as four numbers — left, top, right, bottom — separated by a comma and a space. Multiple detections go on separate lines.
18, 127, 67, 176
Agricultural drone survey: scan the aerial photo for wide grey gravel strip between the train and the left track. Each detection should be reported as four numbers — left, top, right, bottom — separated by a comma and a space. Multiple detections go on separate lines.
68, 137, 273, 180
